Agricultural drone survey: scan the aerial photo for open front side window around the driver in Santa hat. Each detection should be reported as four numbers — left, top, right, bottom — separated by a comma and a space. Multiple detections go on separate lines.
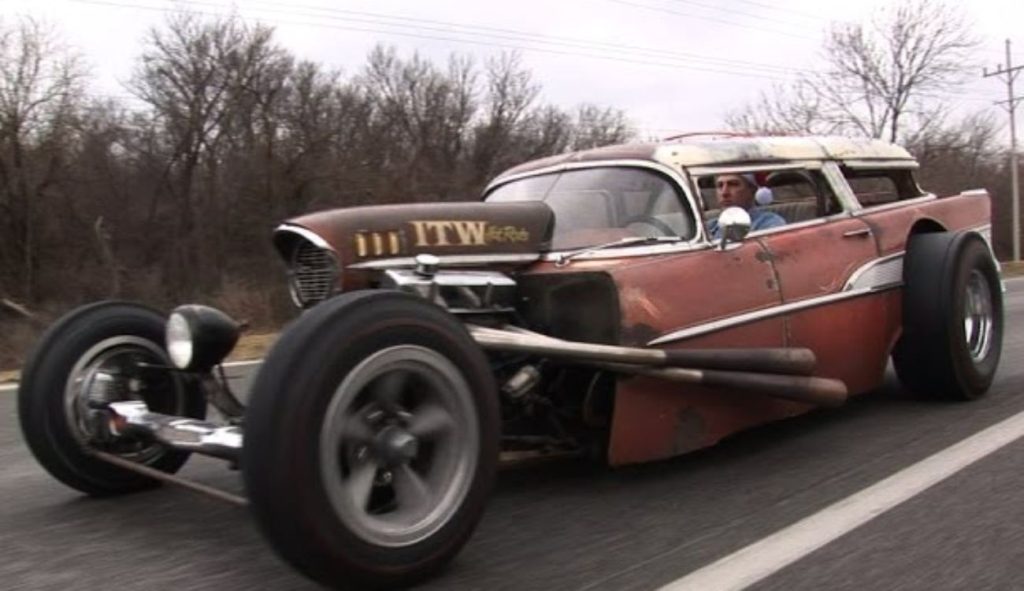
697, 169, 842, 224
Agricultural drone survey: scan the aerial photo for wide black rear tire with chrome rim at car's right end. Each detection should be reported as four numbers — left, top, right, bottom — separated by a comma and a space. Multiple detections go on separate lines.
893, 231, 1004, 400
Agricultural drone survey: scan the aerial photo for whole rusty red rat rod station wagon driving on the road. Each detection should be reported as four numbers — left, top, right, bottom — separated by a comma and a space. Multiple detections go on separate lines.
19, 135, 1002, 587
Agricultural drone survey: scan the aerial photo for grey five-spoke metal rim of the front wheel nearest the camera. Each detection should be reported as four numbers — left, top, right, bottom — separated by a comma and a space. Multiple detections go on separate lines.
319, 345, 479, 547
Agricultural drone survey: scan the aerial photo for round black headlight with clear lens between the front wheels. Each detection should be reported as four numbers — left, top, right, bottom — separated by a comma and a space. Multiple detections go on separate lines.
166, 304, 239, 372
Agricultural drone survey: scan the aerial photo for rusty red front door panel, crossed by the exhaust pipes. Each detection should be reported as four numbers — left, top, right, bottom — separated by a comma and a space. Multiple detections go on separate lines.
608, 241, 786, 465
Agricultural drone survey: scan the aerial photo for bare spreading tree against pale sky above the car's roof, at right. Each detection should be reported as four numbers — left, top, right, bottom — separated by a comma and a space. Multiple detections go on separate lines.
727, 0, 977, 141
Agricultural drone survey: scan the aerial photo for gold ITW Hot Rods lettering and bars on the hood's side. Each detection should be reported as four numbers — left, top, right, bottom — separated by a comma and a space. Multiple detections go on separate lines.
355, 220, 529, 257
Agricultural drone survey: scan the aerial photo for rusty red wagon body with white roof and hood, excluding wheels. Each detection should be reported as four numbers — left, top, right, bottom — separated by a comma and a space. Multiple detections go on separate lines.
285, 133, 990, 465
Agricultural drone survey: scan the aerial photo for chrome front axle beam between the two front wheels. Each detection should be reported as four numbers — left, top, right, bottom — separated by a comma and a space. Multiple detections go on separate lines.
106, 400, 242, 461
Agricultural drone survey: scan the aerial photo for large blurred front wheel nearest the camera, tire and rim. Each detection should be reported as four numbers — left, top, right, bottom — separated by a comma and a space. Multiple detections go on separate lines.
242, 292, 500, 588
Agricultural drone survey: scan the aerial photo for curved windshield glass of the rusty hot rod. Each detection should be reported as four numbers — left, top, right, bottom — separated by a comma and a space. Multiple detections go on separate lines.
485, 167, 695, 250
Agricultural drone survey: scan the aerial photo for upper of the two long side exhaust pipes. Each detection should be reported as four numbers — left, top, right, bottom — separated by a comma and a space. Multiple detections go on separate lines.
468, 326, 817, 376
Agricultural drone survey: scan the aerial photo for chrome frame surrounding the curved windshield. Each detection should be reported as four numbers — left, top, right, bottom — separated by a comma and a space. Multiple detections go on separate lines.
481, 160, 709, 260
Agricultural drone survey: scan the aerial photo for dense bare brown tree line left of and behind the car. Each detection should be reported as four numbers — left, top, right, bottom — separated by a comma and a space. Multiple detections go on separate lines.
0, 13, 633, 325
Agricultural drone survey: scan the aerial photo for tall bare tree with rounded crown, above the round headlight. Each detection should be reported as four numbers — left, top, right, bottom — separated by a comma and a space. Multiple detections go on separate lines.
129, 13, 287, 292
